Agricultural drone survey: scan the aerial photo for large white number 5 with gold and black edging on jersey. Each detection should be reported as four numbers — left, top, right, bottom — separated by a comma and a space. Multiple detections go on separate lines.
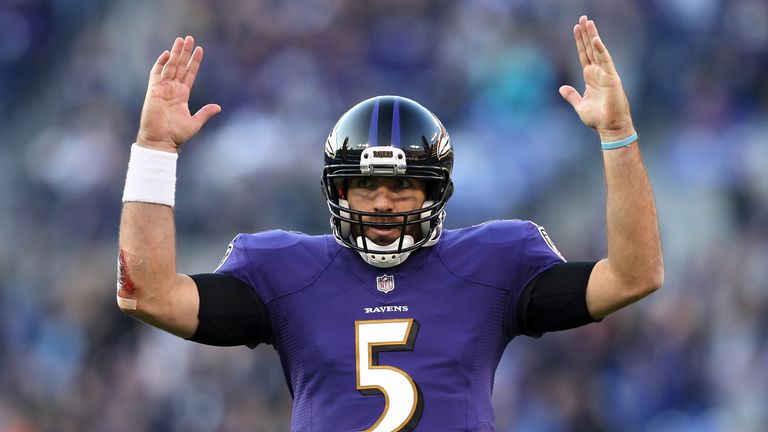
355, 318, 423, 432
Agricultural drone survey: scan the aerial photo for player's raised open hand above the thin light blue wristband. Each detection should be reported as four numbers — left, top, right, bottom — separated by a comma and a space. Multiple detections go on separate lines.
560, 15, 635, 142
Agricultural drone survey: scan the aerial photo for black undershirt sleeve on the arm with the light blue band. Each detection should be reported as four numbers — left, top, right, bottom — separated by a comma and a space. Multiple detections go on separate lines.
517, 262, 596, 337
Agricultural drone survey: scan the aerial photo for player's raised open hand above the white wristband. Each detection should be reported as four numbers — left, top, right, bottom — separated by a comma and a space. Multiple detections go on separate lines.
136, 36, 221, 152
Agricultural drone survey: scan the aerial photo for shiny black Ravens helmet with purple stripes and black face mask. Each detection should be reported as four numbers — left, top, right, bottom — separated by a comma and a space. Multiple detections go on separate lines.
322, 96, 453, 267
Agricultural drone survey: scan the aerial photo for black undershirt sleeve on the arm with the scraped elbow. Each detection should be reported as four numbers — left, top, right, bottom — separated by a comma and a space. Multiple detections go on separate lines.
189, 273, 272, 348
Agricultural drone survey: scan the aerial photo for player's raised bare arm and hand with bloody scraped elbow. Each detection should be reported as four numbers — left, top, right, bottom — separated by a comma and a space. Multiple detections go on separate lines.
117, 36, 221, 338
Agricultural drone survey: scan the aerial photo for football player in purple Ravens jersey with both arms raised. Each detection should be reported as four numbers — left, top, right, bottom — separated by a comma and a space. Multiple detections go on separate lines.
117, 16, 663, 431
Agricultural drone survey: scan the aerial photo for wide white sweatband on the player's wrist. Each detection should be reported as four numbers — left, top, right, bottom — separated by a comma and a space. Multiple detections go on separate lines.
123, 144, 179, 207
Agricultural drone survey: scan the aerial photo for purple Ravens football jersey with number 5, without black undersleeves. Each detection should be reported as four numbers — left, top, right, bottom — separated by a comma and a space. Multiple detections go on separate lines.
216, 220, 564, 431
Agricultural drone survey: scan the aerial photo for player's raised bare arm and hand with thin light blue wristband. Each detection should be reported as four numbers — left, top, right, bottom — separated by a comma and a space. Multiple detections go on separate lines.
560, 16, 664, 319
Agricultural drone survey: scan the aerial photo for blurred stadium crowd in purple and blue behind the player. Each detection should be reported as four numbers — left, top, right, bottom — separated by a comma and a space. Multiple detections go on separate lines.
0, 0, 768, 432
